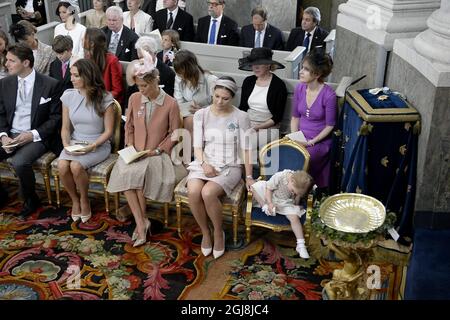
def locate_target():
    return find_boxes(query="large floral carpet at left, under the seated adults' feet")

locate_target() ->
[0,192,202,300]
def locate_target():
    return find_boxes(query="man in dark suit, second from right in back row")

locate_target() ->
[239,7,284,50]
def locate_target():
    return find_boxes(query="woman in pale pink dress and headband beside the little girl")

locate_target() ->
[187,76,254,259]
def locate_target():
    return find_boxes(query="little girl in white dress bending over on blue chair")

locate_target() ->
[251,170,313,259]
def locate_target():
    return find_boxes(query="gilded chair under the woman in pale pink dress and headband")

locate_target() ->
[174,177,246,246]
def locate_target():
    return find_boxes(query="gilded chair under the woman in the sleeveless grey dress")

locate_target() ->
[52,100,122,213]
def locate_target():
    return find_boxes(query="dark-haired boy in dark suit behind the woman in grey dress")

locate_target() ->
[49,35,73,95]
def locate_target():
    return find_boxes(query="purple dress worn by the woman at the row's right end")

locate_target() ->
[292,83,337,188]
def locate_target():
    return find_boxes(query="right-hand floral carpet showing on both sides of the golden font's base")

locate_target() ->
[221,239,407,300]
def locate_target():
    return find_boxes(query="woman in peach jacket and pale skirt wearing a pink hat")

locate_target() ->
[107,53,180,247]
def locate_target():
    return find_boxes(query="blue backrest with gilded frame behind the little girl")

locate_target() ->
[259,138,310,180]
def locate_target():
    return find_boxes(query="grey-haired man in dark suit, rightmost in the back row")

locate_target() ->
[286,7,329,53]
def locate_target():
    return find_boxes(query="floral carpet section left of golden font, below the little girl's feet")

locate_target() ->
[224,240,332,300]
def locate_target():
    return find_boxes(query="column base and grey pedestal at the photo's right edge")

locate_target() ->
[387,0,450,227]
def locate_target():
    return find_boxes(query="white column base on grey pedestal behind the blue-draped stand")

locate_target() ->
[332,0,440,88]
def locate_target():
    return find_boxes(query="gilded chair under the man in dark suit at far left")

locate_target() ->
[0,151,56,205]
